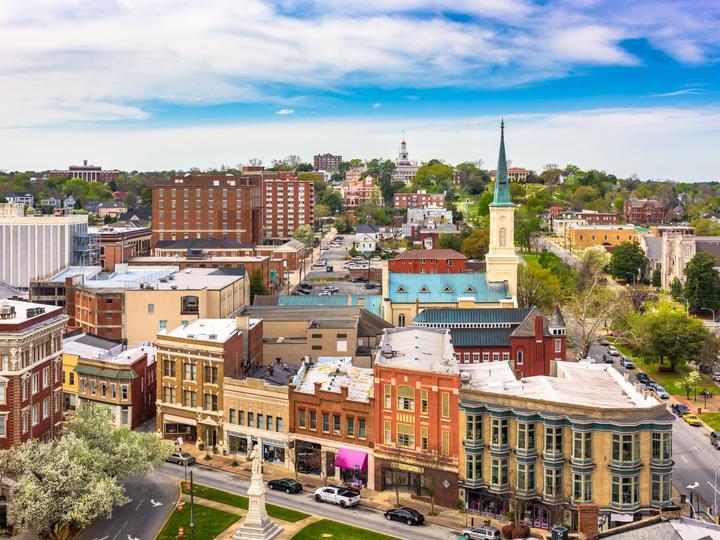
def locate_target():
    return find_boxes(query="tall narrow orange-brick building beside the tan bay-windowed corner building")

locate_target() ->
[374,328,460,507]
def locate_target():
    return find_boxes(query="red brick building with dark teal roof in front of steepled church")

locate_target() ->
[414,308,567,378]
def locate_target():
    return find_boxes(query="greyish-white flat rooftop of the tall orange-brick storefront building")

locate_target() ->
[375,326,459,374]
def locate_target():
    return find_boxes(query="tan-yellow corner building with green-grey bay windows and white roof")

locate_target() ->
[460,362,674,530]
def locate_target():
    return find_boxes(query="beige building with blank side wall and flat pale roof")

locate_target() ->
[124,268,250,344]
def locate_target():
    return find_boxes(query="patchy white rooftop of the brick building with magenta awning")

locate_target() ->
[293,356,375,403]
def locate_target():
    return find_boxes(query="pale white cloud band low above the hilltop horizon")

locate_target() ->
[0,107,720,181]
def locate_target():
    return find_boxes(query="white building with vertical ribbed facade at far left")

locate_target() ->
[0,204,89,289]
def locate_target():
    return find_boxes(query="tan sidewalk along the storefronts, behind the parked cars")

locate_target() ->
[183,445,550,538]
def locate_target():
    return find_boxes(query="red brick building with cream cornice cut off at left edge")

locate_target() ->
[0,300,66,450]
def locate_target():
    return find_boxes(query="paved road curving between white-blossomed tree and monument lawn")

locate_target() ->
[80,471,177,540]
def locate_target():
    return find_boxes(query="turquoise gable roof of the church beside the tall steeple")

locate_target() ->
[387,272,508,304]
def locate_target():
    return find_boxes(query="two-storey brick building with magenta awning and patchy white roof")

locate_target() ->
[288,357,375,489]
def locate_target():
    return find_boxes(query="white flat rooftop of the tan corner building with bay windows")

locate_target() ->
[460,361,660,409]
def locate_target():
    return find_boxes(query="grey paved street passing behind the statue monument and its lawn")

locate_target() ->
[158,463,455,540]
